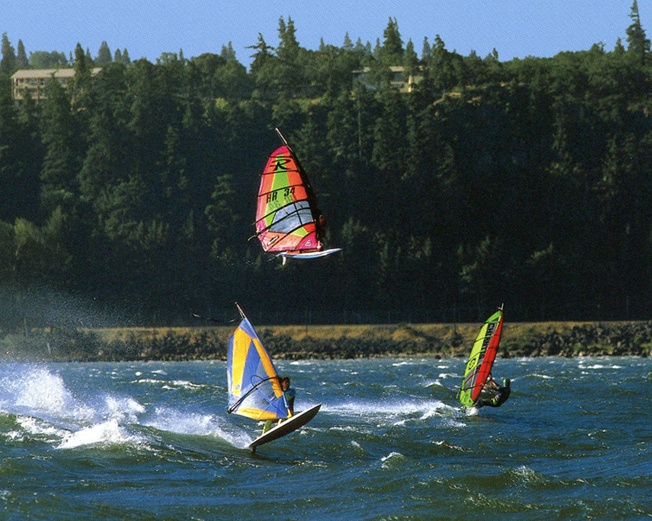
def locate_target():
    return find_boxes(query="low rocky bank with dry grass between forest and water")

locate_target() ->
[1,321,652,361]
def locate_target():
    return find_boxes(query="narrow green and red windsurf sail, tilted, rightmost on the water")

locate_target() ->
[459,308,503,407]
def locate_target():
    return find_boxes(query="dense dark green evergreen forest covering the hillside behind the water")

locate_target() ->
[0,6,652,330]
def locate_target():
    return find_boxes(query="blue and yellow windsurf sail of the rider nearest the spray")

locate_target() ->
[227,315,287,420]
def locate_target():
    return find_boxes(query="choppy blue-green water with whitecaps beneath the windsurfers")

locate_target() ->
[0,358,652,520]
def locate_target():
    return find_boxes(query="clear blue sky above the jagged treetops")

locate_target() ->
[5,0,652,67]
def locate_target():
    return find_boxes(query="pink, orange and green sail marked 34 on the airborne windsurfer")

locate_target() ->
[256,129,322,253]
